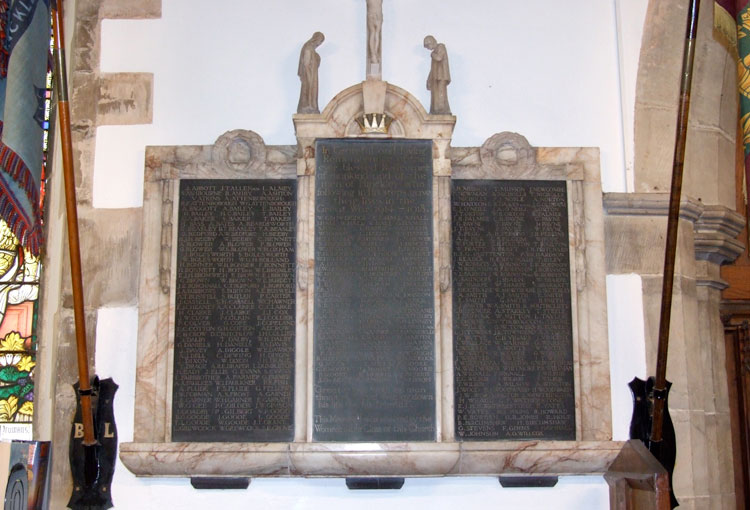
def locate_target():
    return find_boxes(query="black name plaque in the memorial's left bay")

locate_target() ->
[172,179,297,442]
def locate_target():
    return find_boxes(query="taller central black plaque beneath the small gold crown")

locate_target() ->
[313,140,435,441]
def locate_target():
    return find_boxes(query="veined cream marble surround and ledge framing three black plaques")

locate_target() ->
[120,71,623,477]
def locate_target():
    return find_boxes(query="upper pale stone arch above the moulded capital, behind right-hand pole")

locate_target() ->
[634,0,737,209]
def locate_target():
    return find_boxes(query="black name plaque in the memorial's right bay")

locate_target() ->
[451,180,576,440]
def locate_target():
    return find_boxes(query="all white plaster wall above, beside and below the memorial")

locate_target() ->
[93,0,645,510]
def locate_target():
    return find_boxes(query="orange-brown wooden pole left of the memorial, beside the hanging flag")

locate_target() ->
[52,0,96,446]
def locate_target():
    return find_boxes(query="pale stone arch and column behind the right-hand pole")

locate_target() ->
[628,0,741,506]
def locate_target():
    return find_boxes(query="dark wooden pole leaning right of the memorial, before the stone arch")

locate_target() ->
[651,0,700,442]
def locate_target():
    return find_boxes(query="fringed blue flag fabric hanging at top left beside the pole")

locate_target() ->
[0,0,50,255]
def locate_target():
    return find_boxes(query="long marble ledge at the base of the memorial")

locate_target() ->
[120,441,625,477]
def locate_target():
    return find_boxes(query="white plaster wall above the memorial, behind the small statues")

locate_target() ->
[94,0,636,207]
